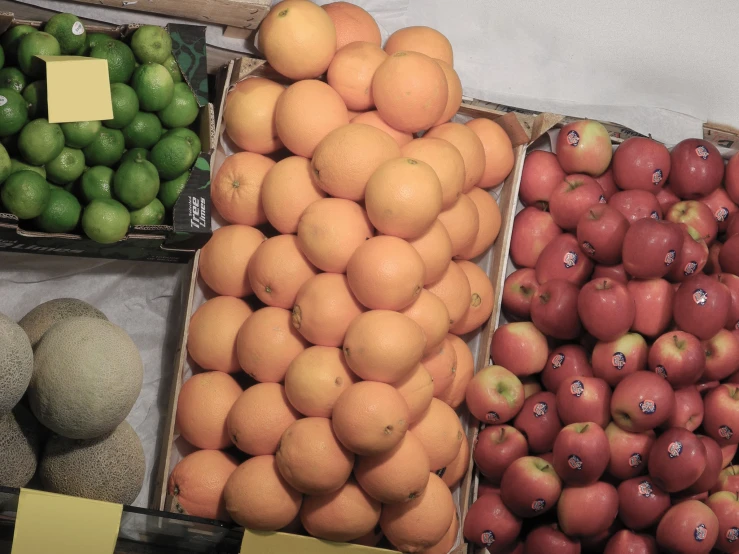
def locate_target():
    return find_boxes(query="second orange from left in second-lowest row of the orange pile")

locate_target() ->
[227,383,300,456]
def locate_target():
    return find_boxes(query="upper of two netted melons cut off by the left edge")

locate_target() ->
[0,314,33,414]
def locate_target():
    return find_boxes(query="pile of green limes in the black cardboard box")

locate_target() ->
[0,14,201,243]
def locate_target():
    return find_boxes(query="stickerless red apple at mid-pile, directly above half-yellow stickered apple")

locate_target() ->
[577,279,636,341]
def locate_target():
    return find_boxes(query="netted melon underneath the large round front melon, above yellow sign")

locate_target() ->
[39,421,146,504]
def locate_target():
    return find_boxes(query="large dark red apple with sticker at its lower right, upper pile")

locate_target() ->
[622,218,684,279]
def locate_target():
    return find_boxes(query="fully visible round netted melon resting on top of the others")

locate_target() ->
[28,317,144,439]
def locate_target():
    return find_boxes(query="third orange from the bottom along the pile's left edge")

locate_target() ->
[187,296,252,373]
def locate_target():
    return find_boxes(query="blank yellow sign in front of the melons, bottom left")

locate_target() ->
[11,489,123,554]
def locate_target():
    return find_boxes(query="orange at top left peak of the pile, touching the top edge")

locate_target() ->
[259,0,336,80]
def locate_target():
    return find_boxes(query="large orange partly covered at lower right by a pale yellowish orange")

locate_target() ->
[311,123,400,201]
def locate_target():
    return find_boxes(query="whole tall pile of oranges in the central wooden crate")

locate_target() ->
[169,0,513,553]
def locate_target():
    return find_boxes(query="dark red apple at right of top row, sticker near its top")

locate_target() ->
[670,139,724,200]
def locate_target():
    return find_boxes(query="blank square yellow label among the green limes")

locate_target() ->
[39,56,113,123]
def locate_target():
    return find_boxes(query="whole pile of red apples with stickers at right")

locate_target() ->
[464,121,739,554]
